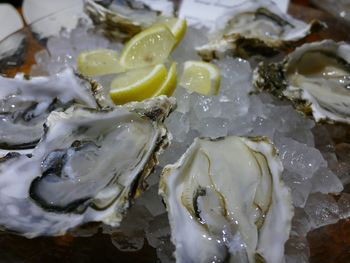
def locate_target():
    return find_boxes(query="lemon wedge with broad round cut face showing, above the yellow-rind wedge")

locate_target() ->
[120,25,176,68]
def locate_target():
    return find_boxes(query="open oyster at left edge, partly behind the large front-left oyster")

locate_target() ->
[0,69,97,153]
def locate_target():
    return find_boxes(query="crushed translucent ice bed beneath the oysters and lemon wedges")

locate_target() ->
[31,23,350,262]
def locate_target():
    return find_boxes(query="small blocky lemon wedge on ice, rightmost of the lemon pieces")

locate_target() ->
[180,61,221,96]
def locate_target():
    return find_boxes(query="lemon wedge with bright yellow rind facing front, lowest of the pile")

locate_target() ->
[110,64,167,104]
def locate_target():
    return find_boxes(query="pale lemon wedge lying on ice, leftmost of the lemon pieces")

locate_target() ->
[77,49,124,77]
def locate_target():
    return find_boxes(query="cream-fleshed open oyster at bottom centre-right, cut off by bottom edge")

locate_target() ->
[159,136,293,263]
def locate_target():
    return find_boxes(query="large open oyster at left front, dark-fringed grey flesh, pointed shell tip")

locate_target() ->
[0,96,174,237]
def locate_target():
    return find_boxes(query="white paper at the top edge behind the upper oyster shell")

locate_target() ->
[179,0,289,27]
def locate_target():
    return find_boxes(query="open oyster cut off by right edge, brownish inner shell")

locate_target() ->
[253,40,350,124]
